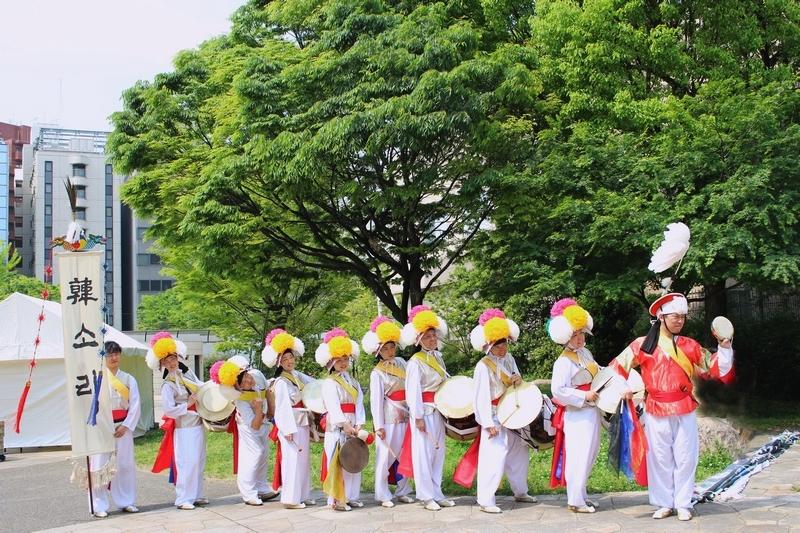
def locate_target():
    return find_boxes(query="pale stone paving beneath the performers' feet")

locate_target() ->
[40,445,800,533]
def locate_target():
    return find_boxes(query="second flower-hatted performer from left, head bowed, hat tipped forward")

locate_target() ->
[218,355,277,505]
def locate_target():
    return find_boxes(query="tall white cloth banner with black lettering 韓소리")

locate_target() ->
[55,251,114,457]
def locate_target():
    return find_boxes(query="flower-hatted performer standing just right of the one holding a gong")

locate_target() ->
[361,316,414,507]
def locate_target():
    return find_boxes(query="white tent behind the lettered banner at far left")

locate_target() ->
[0,293,153,448]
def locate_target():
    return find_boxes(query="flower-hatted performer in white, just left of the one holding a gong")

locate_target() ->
[261,329,316,509]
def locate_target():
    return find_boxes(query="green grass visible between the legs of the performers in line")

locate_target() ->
[135,424,732,496]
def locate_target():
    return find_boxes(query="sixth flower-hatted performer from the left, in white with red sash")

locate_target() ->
[399,305,456,511]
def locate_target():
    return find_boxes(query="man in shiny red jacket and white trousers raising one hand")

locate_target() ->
[610,293,734,520]
